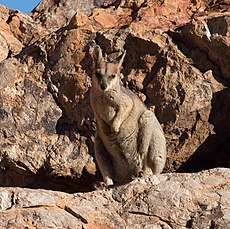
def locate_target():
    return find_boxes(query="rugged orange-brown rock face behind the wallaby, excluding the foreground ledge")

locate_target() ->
[0,0,230,202]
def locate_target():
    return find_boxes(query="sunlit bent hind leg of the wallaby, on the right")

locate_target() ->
[138,110,166,174]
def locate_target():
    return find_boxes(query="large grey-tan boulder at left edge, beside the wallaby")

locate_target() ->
[0,59,95,191]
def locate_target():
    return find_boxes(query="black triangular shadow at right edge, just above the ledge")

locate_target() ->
[178,88,230,172]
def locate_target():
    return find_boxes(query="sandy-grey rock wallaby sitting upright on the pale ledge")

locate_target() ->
[90,46,166,186]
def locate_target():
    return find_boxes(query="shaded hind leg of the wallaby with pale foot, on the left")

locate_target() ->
[94,133,113,186]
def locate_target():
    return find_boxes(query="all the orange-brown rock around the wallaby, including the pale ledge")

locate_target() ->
[0,0,230,226]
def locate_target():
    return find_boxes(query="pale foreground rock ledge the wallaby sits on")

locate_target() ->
[0,168,230,229]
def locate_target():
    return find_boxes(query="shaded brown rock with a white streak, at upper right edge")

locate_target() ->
[169,12,230,80]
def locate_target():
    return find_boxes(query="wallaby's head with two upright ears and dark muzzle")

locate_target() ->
[92,46,126,91]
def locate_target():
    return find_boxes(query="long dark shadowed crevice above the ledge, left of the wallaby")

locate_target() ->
[0,156,96,193]
